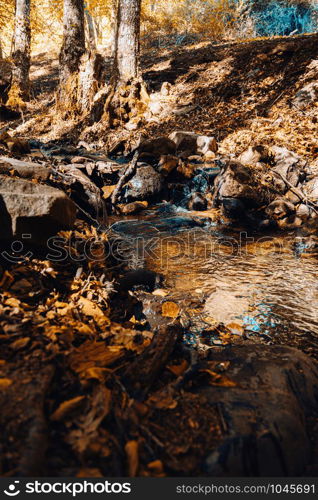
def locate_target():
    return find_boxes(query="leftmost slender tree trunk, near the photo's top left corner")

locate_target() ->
[8,0,31,106]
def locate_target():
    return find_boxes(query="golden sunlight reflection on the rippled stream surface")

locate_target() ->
[146,230,318,335]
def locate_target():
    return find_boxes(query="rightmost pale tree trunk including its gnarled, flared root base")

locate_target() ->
[82,0,150,138]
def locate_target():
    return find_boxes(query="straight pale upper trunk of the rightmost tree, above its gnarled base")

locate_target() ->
[115,0,141,82]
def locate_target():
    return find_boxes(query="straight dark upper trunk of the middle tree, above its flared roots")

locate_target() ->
[60,0,85,84]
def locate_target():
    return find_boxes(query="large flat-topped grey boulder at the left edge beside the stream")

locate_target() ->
[0,176,76,244]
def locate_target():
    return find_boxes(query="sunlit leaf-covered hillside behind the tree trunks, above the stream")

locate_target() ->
[11,34,318,166]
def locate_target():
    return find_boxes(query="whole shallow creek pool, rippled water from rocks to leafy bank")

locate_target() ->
[110,207,318,348]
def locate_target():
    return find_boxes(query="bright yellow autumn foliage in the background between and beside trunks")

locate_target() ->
[0,0,256,57]
